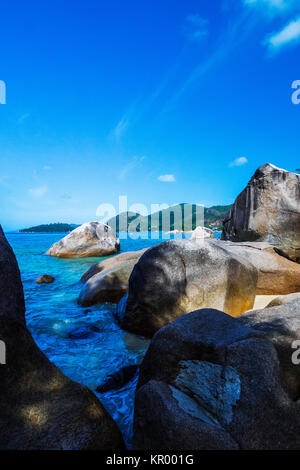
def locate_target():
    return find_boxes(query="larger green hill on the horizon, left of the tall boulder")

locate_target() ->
[107,203,231,232]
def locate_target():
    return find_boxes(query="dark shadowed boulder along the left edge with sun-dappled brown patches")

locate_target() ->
[0,227,124,450]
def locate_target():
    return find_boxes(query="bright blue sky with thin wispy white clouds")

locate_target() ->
[0,0,300,230]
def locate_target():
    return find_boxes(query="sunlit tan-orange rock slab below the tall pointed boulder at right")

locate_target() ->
[219,240,300,295]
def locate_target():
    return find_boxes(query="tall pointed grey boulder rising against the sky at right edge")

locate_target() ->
[222,163,300,262]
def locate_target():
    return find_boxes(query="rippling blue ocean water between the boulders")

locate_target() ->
[6,233,220,447]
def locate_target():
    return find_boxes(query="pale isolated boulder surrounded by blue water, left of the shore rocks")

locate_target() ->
[46,222,120,258]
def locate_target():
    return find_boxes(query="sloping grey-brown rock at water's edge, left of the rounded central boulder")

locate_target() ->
[78,249,146,306]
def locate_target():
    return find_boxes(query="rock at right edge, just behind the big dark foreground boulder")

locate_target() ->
[238,302,300,400]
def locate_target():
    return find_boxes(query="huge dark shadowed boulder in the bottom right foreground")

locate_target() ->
[133,309,300,451]
